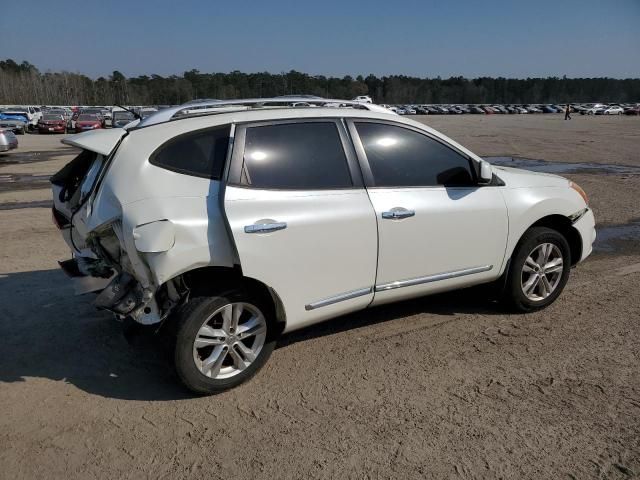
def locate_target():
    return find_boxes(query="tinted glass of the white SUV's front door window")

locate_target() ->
[356,122,474,187]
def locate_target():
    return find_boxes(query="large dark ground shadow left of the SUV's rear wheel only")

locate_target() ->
[0,270,192,401]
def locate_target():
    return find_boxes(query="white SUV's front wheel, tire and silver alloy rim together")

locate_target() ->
[505,227,571,312]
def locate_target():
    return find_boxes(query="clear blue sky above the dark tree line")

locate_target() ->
[0,0,640,78]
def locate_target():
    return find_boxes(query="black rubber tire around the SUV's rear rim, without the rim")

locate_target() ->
[173,290,277,395]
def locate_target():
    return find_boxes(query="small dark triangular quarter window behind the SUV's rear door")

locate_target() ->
[149,125,231,180]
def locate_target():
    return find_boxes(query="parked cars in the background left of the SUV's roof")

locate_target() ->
[0,105,158,135]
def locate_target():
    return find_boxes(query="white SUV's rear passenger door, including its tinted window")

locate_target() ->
[224,119,377,330]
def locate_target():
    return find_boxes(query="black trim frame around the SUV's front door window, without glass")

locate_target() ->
[345,117,482,189]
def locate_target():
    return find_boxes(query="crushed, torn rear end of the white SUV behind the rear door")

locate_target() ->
[51,125,233,325]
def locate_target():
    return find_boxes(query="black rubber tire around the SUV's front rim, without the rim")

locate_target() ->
[503,227,571,312]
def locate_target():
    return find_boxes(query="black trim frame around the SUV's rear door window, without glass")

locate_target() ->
[227,117,364,192]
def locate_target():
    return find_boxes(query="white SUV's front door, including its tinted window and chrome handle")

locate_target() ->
[351,121,508,304]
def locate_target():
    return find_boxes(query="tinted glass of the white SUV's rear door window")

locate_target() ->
[241,122,352,190]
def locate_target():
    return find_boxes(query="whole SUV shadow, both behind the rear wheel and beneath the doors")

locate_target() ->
[0,270,501,401]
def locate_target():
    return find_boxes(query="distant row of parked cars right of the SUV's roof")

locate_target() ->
[382,103,640,115]
